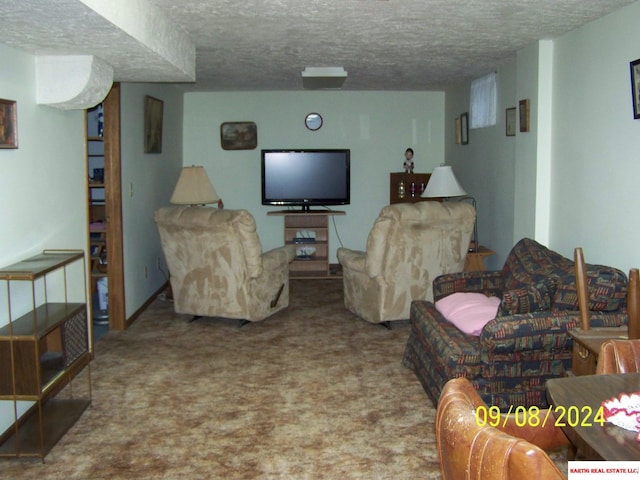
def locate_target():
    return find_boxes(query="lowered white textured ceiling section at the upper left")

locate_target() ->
[0,0,195,82]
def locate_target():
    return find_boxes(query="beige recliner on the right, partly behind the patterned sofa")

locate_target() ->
[338,202,475,325]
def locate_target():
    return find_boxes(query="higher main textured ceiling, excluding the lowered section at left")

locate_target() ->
[153,0,631,90]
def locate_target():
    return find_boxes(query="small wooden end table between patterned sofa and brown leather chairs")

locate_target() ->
[567,325,628,376]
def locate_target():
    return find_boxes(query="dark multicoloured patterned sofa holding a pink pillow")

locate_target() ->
[402,238,627,409]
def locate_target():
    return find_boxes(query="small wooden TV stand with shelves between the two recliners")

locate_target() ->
[267,210,346,279]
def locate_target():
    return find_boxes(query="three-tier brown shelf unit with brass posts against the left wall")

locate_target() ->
[0,250,92,462]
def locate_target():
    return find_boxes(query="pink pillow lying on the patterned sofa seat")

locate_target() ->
[435,292,500,336]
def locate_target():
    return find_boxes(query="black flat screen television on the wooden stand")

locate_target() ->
[261,149,351,210]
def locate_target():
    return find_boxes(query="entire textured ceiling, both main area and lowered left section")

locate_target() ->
[0,0,633,90]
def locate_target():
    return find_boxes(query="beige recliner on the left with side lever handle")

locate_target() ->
[154,207,295,322]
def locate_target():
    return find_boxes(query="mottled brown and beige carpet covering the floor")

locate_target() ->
[0,280,448,480]
